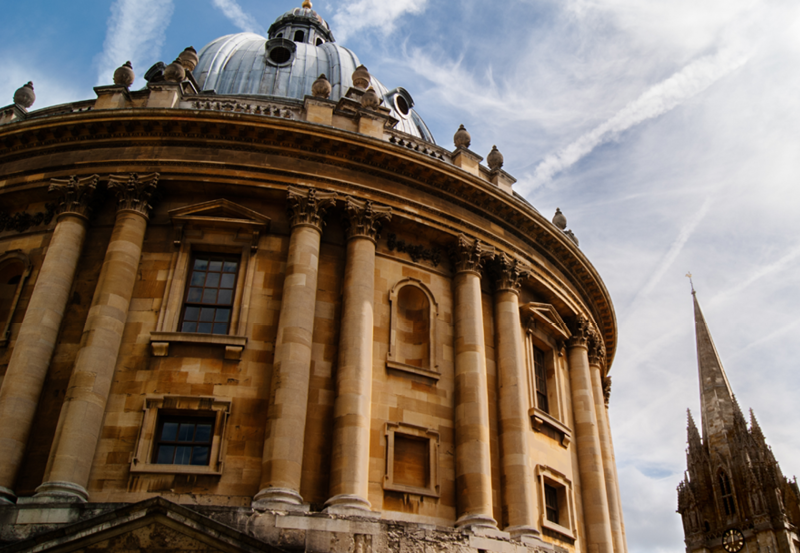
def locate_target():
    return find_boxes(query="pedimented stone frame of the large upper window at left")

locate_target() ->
[150,199,270,361]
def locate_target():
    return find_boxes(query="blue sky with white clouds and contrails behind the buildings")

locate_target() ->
[0,0,800,553]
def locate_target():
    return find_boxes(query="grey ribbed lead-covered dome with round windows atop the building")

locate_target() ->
[193,2,435,142]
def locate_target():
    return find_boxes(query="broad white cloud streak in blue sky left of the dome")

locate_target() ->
[97,0,174,86]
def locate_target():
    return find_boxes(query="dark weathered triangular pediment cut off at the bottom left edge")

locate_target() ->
[8,497,278,553]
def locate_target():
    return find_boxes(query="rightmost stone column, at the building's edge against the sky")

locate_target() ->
[588,332,627,553]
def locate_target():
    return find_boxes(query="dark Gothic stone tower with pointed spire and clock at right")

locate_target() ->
[678,290,800,553]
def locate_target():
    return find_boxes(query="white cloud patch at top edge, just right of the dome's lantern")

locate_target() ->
[333,0,428,41]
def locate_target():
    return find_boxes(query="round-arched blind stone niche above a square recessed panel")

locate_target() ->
[386,278,439,380]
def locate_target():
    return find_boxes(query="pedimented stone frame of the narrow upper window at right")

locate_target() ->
[520,302,572,448]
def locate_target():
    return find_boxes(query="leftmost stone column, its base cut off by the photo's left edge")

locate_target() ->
[0,175,98,504]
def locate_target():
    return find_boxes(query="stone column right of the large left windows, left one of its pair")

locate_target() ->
[253,187,336,508]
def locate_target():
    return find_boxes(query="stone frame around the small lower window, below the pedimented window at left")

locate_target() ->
[130,394,233,476]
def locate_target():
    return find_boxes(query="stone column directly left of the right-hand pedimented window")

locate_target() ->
[493,253,539,537]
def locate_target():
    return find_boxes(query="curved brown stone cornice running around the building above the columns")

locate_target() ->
[0,108,616,366]
